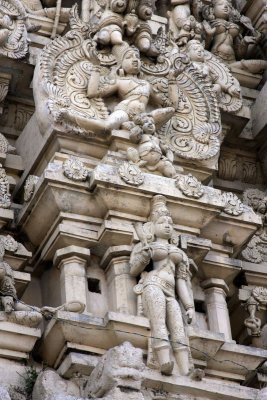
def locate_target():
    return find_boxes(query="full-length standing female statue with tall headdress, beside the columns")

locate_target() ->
[130,195,195,375]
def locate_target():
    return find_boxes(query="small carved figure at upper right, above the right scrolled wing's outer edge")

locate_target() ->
[186,40,240,97]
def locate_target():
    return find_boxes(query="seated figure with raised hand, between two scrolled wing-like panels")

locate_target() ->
[61,43,174,134]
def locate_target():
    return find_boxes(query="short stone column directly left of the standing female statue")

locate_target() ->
[101,246,136,315]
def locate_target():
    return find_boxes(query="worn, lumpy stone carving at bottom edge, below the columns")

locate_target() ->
[32,342,145,400]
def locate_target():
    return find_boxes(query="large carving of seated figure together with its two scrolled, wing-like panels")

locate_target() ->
[34,3,226,160]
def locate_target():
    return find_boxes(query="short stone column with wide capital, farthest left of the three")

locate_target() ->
[54,246,90,305]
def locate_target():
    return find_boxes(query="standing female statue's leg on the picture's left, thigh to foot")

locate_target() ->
[142,285,173,375]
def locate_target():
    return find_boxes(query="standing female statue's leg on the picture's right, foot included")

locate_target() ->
[167,297,190,375]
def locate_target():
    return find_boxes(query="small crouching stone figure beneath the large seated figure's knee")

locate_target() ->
[126,113,177,178]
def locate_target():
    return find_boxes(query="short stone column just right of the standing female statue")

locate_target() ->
[201,278,232,341]
